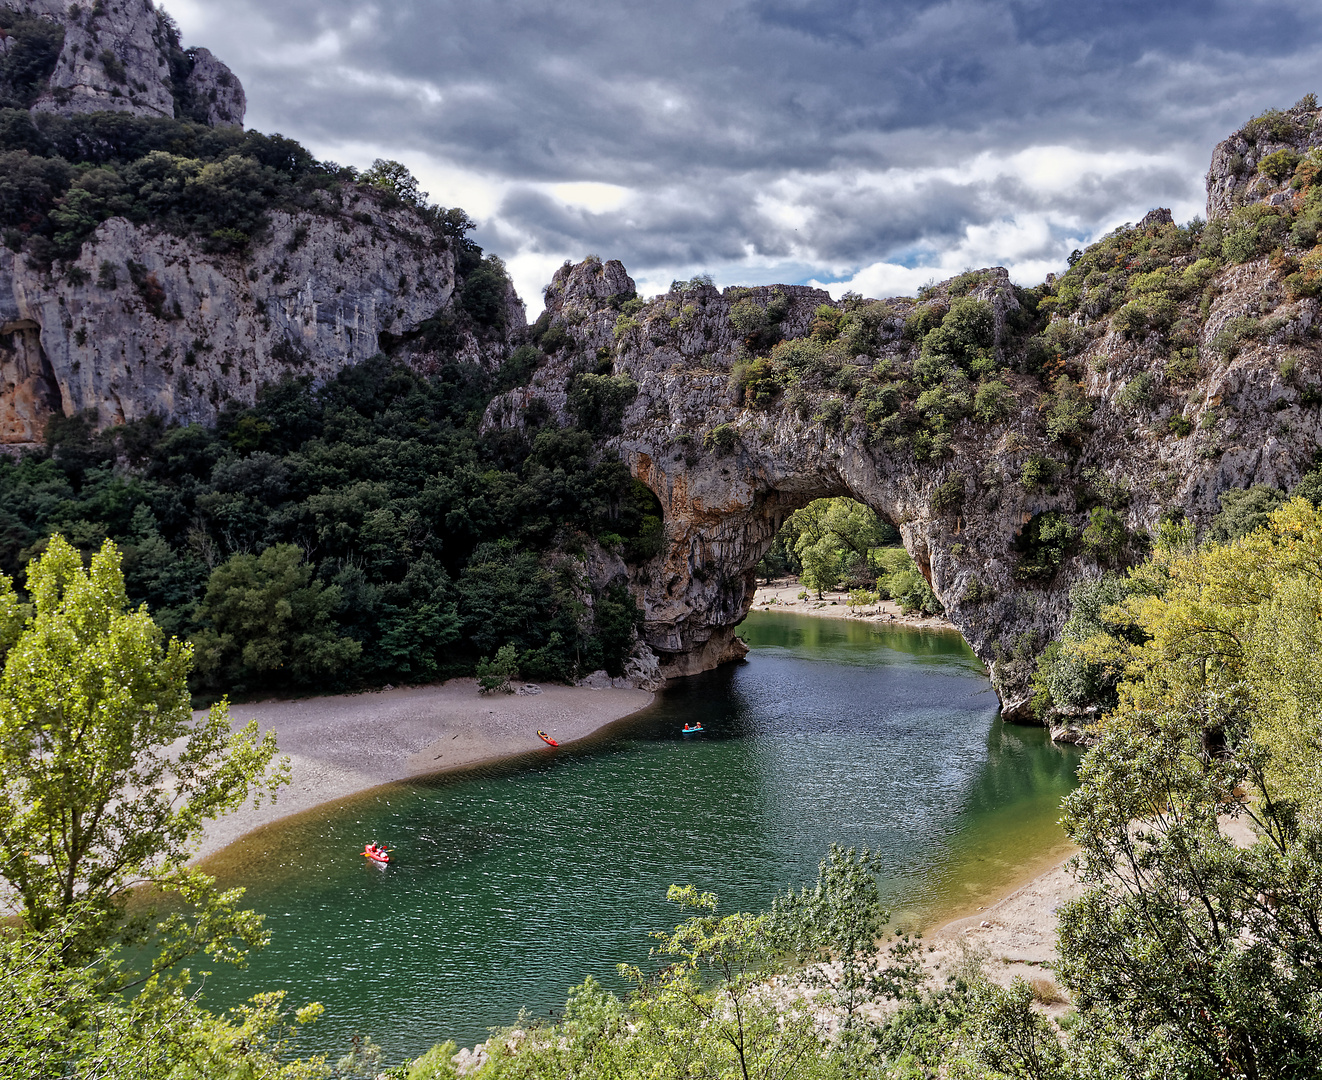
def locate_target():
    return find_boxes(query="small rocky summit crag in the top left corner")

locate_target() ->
[9,0,247,126]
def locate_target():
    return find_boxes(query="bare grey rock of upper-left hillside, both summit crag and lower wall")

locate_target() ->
[0,0,526,448]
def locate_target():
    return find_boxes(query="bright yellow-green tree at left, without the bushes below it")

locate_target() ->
[0,535,288,970]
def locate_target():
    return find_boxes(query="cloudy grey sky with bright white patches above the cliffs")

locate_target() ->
[164,0,1322,313]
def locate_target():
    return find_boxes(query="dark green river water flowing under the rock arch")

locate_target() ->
[198,612,1077,1060]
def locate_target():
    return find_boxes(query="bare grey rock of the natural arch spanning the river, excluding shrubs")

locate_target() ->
[484,251,1322,716]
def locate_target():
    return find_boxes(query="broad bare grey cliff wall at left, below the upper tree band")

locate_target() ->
[0,189,526,444]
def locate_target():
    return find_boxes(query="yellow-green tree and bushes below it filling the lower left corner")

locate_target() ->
[0,535,327,1080]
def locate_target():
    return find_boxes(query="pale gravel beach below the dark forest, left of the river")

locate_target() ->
[197,678,653,859]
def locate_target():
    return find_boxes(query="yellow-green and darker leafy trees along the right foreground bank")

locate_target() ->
[1060,498,1322,1077]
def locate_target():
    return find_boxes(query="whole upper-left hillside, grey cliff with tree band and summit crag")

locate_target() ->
[0,0,526,445]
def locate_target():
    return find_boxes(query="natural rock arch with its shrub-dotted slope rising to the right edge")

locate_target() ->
[485,106,1322,716]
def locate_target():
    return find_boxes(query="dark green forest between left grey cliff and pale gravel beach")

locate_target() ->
[0,358,660,695]
